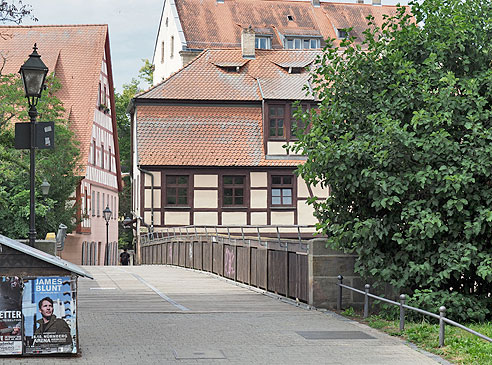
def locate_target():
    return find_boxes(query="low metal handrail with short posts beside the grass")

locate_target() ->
[337,275,492,347]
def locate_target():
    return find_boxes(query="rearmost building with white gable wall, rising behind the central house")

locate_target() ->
[152,0,404,85]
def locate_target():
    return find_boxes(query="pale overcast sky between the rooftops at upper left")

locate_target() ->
[24,0,408,92]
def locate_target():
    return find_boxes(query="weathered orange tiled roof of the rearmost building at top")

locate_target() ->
[175,0,404,49]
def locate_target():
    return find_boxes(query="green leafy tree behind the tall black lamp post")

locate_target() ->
[0,74,79,238]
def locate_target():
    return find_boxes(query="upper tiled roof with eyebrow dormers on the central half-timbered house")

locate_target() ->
[137,49,320,101]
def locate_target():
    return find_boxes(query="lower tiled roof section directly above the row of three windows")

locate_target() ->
[137,105,299,167]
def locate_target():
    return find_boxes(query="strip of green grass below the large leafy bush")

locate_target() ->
[342,308,492,365]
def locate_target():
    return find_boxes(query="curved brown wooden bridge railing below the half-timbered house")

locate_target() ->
[141,226,309,303]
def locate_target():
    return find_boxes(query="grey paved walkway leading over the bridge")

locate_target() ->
[0,266,446,365]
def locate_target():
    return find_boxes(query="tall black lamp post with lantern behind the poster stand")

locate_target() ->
[19,44,48,246]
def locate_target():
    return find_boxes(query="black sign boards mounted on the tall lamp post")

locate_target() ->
[15,122,55,150]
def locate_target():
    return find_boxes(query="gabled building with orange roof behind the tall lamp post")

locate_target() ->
[0,25,122,265]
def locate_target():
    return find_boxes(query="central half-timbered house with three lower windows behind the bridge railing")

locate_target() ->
[131,34,328,242]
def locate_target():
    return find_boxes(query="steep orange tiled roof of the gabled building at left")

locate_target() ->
[0,25,121,186]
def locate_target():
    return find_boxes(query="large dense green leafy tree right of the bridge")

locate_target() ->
[295,0,492,320]
